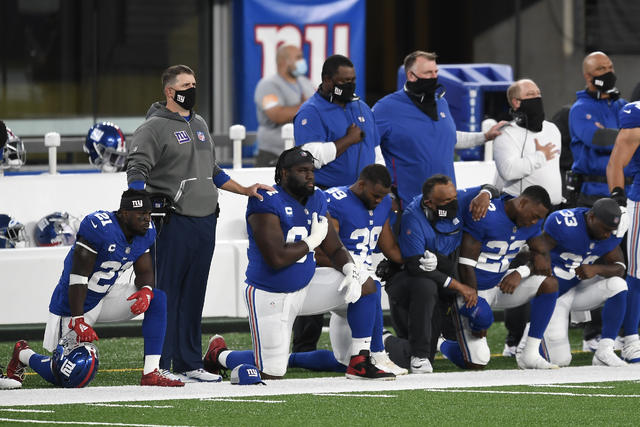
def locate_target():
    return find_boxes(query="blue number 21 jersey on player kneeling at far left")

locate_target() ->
[49,211,156,316]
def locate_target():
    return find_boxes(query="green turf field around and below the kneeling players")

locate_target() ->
[5,323,640,426]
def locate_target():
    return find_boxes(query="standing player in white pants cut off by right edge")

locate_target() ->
[607,101,640,363]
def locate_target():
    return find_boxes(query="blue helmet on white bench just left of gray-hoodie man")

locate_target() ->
[84,122,127,172]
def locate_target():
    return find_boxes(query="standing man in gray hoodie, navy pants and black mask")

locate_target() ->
[127,65,272,381]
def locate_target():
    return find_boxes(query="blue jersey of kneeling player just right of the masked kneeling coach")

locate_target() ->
[463,196,544,290]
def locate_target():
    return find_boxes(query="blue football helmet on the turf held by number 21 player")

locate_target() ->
[51,331,98,388]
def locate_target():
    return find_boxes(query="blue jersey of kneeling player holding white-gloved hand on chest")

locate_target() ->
[246,185,327,292]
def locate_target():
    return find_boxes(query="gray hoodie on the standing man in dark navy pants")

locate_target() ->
[127,102,224,217]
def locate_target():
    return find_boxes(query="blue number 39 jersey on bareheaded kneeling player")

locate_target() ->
[325,186,391,266]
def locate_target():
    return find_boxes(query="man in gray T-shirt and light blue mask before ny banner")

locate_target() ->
[254,45,313,167]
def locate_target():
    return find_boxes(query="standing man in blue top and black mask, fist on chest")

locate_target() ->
[293,55,384,188]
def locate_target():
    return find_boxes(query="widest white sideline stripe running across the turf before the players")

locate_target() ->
[0,365,640,407]
